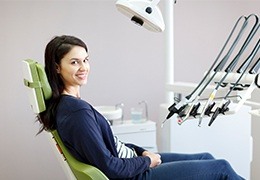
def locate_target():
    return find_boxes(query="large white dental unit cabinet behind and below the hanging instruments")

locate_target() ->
[157,83,253,179]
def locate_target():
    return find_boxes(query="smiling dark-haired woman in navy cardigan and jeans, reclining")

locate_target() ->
[38,35,242,180]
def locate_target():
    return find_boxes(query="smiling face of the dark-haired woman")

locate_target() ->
[57,46,90,89]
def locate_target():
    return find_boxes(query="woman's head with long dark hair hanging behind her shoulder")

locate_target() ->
[38,35,90,133]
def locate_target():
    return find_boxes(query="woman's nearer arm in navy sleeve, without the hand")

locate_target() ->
[59,109,151,178]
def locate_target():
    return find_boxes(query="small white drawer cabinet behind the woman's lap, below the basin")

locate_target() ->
[111,121,157,152]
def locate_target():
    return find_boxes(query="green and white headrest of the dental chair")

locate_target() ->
[23,59,52,113]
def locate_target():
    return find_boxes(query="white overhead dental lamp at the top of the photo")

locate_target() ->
[116,0,165,32]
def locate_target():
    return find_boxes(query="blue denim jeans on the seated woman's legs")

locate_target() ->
[143,153,243,180]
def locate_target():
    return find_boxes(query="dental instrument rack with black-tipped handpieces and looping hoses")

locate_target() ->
[165,14,260,126]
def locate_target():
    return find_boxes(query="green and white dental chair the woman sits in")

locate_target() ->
[23,59,108,180]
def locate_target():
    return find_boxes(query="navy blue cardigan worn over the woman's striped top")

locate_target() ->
[56,95,151,179]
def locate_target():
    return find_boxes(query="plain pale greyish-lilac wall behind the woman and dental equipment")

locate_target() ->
[0,0,260,180]
